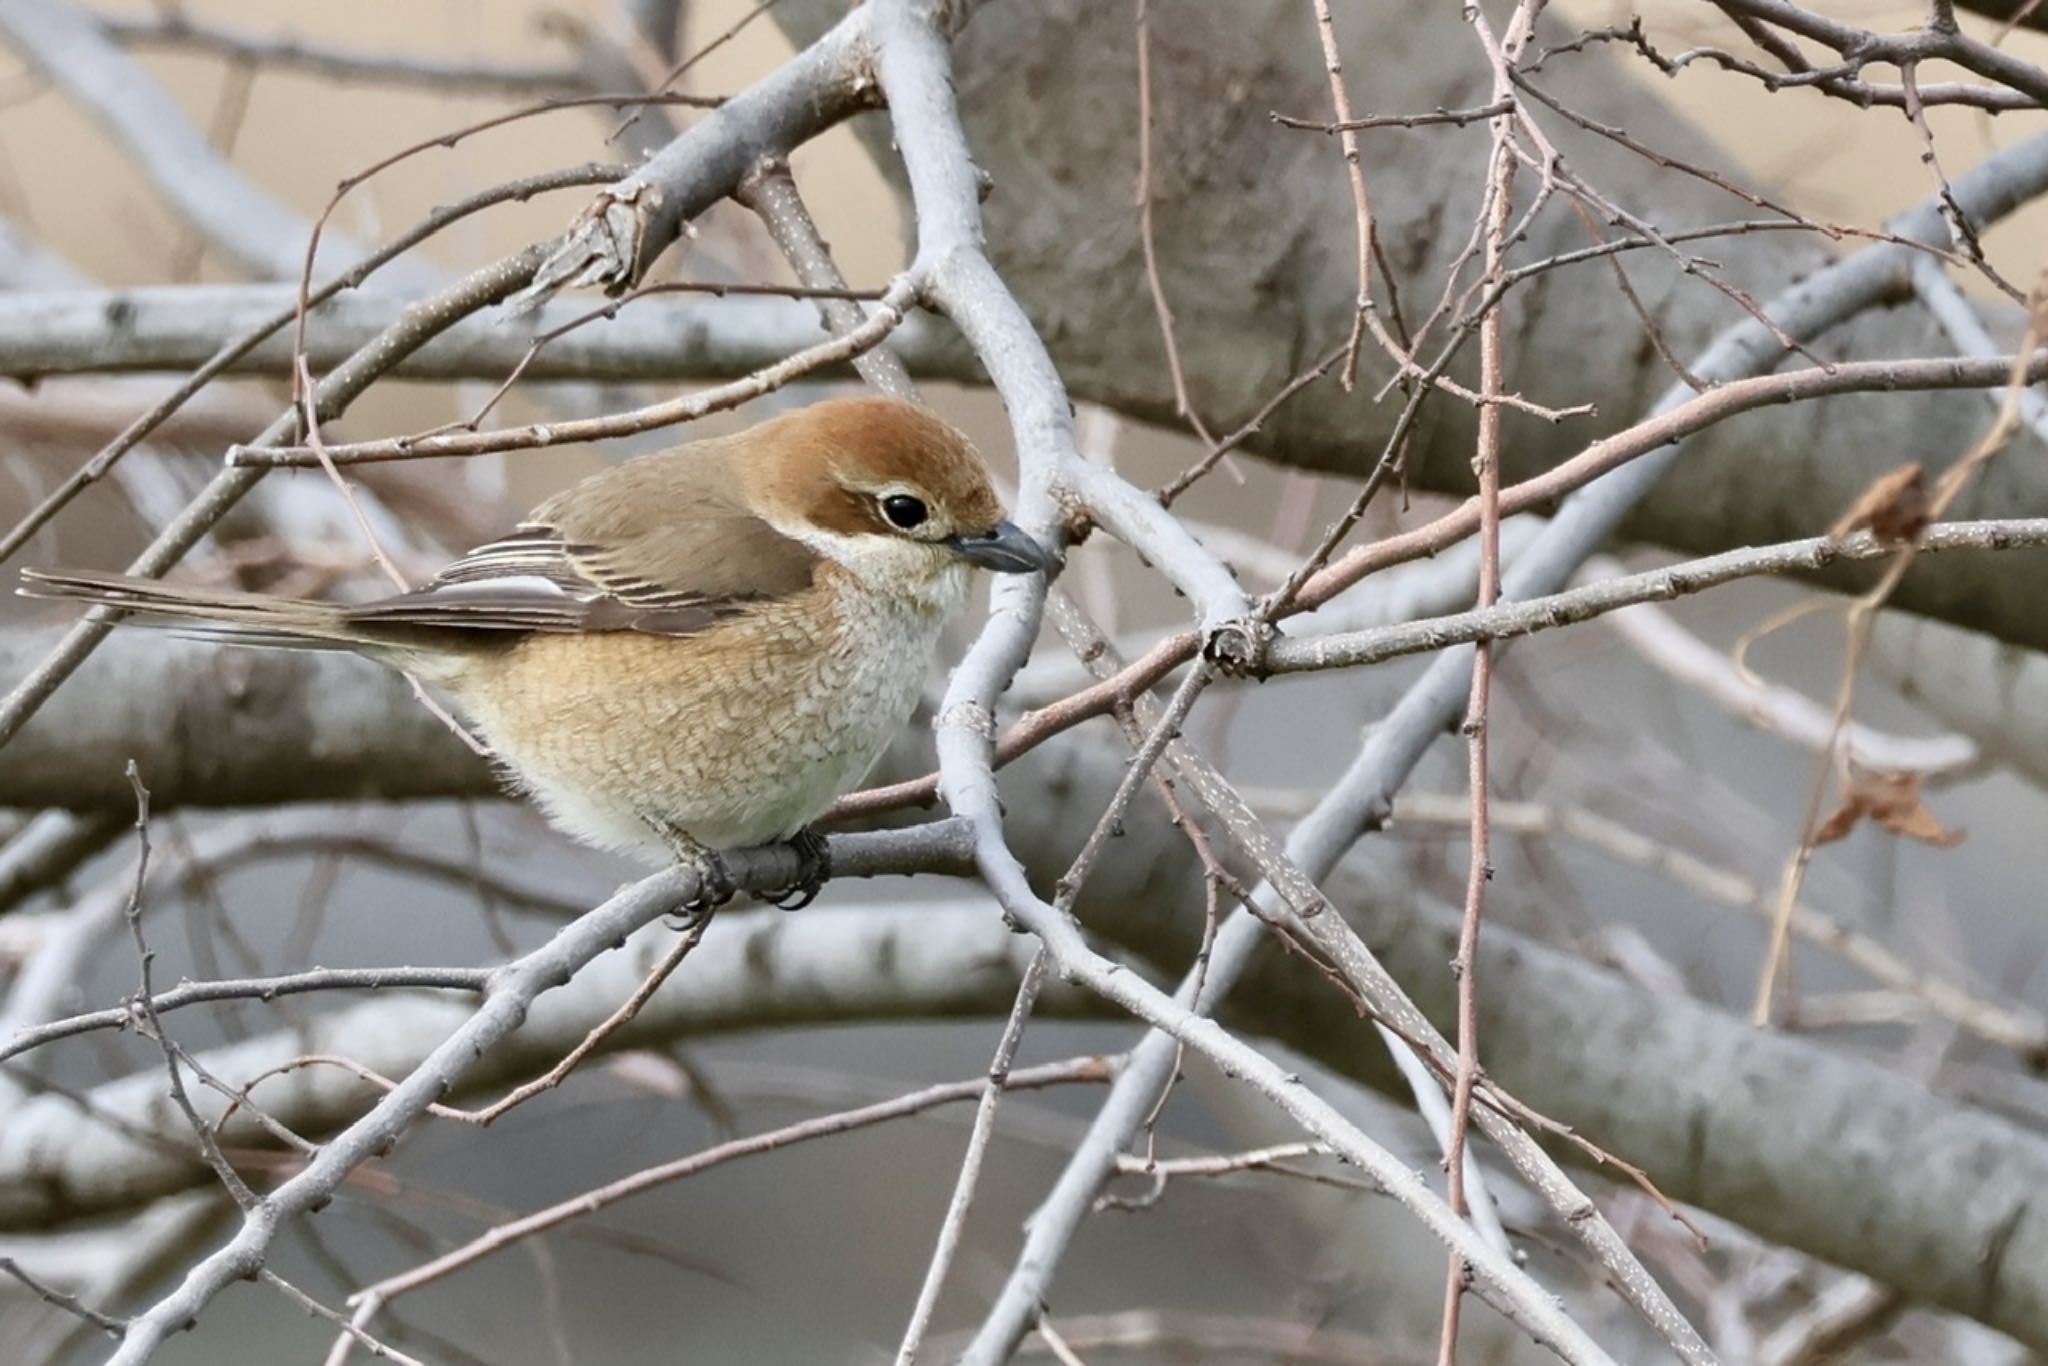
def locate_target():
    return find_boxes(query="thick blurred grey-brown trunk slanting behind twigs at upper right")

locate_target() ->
[774,0,2048,649]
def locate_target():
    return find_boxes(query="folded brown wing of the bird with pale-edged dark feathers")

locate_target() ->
[348,508,813,635]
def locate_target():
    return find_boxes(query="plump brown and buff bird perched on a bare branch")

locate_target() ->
[20,395,1055,905]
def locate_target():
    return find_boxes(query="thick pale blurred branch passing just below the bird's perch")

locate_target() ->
[0,903,1102,1231]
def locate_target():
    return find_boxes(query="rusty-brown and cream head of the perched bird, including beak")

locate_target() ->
[741,397,1053,608]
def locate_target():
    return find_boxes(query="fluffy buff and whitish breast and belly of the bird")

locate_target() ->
[451,573,944,862]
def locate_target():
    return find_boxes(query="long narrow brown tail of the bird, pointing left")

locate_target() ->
[20,569,370,649]
